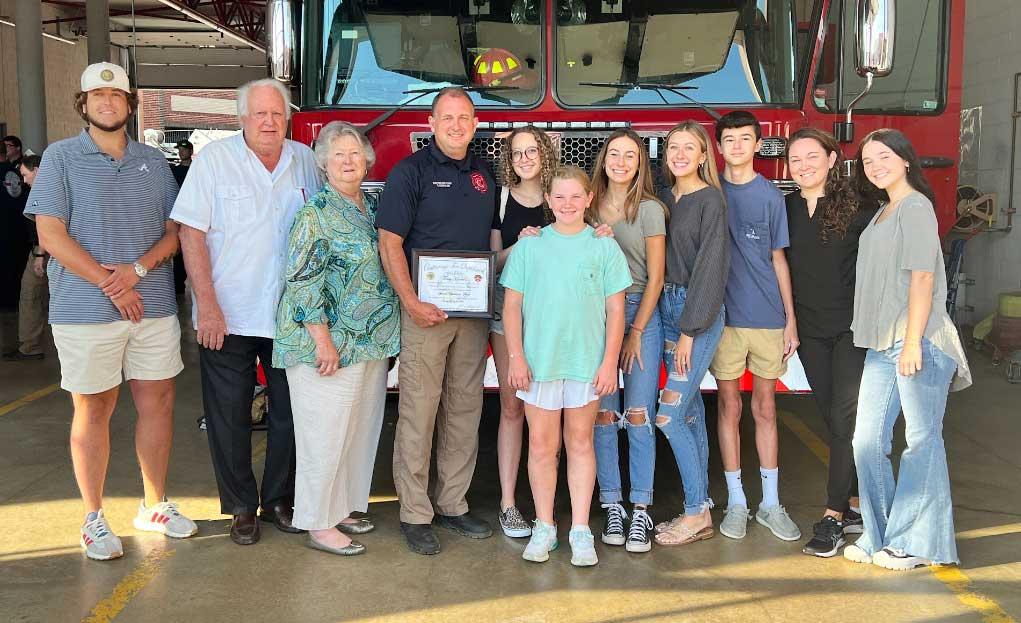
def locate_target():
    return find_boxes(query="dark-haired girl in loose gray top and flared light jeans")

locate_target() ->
[844,130,971,570]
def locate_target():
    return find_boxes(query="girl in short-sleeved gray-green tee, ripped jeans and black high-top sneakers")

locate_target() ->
[586,130,667,552]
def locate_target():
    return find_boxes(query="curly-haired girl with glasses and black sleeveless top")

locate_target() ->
[489,126,556,537]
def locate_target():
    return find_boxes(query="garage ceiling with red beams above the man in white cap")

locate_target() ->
[43,0,266,88]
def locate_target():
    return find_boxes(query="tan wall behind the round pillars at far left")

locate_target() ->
[0,0,89,152]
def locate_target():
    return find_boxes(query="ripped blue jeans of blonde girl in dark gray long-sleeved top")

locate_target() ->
[655,283,724,515]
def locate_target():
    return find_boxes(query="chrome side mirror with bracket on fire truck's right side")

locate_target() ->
[833,0,896,143]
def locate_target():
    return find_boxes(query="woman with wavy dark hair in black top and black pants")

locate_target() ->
[786,128,875,558]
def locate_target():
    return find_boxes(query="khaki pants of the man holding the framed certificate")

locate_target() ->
[393,313,489,524]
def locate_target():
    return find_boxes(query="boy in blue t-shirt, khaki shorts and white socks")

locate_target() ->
[710,110,801,540]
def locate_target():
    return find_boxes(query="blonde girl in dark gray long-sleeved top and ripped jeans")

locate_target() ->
[655,121,730,545]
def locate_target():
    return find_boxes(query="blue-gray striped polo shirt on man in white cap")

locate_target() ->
[25,130,178,325]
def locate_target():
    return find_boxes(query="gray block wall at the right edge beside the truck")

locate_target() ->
[961,0,1021,322]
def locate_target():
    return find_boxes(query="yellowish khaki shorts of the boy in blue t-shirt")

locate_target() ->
[709,327,787,381]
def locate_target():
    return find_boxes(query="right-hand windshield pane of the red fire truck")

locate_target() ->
[553,0,797,107]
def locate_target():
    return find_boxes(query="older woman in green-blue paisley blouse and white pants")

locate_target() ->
[273,122,400,556]
